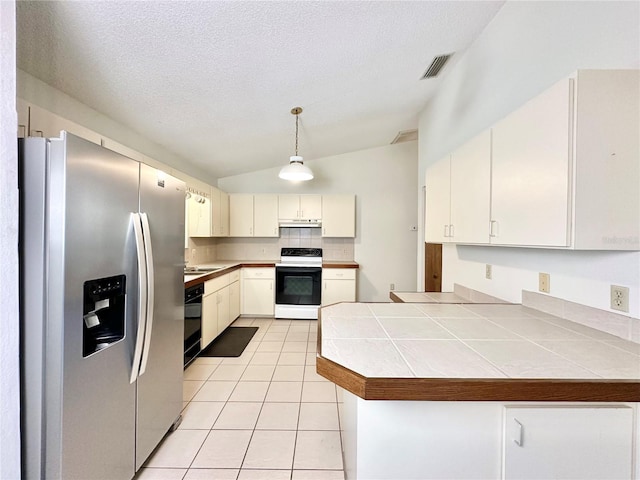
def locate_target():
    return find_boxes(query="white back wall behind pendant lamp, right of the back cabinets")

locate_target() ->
[218,142,418,302]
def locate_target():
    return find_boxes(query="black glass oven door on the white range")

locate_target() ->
[276,266,322,307]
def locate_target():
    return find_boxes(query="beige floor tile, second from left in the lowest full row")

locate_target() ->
[191,430,253,468]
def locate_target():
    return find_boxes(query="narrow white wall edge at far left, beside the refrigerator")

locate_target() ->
[0,0,20,479]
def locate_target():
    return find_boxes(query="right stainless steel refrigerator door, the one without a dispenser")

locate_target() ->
[136,164,185,470]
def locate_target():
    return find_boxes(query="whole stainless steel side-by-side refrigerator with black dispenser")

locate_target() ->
[19,132,185,480]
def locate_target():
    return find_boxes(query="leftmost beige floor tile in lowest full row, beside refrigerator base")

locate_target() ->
[147,429,209,468]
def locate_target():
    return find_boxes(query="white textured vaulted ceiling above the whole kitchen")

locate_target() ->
[17,1,504,178]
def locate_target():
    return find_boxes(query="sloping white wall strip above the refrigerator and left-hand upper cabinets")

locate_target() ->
[17,69,215,184]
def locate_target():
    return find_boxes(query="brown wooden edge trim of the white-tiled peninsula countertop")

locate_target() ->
[316,310,640,402]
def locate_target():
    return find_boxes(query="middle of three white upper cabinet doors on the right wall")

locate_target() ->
[449,130,491,244]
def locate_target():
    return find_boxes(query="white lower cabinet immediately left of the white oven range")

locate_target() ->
[241,267,276,315]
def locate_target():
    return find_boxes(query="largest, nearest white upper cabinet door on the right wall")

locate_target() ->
[491,79,573,246]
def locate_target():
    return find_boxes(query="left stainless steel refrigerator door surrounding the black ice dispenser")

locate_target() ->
[56,135,138,479]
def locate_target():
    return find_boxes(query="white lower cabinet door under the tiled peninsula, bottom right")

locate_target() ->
[503,406,633,480]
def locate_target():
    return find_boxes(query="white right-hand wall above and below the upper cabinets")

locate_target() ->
[419,1,640,318]
